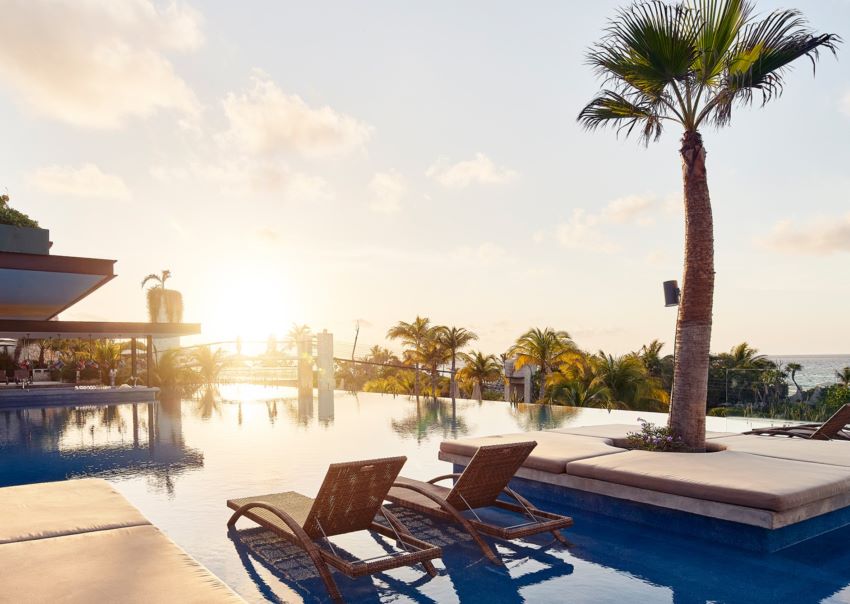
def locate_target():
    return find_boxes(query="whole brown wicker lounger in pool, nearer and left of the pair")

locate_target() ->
[227,457,441,600]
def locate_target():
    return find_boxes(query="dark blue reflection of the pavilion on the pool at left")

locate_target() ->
[0,399,204,492]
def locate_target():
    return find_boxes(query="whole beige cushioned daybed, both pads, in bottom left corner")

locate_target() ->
[0,478,244,604]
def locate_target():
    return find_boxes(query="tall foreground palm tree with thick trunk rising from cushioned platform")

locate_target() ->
[578,0,840,450]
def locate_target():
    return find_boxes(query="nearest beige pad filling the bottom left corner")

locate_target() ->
[0,525,243,604]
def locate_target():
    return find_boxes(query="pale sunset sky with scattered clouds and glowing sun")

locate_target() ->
[0,0,850,354]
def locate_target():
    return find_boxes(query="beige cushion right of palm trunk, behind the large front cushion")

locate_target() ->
[715,434,850,467]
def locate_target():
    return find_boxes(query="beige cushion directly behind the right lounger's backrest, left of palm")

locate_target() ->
[440,432,623,474]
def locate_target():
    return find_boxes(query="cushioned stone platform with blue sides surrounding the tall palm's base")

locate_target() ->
[439,424,850,551]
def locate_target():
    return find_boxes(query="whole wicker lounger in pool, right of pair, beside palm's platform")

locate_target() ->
[387,441,573,564]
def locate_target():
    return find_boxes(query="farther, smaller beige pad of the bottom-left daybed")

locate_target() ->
[0,478,150,543]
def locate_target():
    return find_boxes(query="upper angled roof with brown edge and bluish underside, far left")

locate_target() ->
[0,252,115,320]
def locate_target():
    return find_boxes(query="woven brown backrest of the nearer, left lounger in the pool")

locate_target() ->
[304,456,407,538]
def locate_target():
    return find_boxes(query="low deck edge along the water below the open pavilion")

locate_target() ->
[0,384,159,409]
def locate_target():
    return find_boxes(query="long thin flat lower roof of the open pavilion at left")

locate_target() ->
[0,319,201,340]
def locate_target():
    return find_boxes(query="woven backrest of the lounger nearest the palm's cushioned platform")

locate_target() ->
[446,441,537,510]
